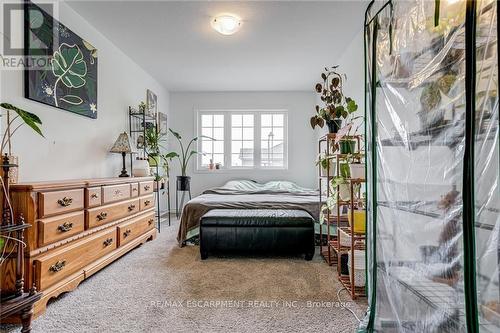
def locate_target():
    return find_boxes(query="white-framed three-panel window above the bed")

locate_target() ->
[198,110,288,170]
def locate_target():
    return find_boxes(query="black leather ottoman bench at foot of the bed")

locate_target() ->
[200,209,314,260]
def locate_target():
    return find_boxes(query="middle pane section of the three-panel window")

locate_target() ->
[231,114,254,167]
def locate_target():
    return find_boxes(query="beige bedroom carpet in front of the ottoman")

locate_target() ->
[0,218,366,333]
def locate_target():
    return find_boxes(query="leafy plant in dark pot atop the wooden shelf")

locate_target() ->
[310,66,358,133]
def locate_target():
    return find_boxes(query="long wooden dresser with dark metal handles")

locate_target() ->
[0,177,156,317]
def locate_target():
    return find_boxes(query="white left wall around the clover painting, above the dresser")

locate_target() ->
[0,3,169,181]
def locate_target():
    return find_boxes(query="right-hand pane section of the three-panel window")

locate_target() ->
[260,114,285,168]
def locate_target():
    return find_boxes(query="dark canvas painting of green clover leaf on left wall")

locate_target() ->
[24,2,97,119]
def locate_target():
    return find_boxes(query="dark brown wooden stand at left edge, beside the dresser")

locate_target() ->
[0,154,42,333]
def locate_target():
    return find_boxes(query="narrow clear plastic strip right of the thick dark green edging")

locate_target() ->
[474,1,500,332]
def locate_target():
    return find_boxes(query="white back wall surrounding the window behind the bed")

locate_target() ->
[170,89,317,195]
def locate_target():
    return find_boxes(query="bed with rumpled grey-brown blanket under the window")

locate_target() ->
[177,180,320,246]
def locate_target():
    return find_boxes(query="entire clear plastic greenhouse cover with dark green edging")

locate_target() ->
[362,0,500,333]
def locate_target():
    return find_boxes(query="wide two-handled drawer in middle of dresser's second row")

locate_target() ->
[85,198,139,229]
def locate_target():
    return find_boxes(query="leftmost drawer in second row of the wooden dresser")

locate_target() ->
[38,211,85,246]
